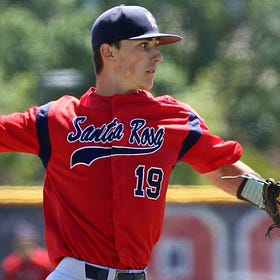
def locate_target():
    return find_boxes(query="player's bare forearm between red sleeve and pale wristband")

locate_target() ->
[203,160,261,196]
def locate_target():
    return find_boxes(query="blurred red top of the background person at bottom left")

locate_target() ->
[2,247,52,280]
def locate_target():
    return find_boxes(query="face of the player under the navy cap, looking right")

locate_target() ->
[112,39,163,92]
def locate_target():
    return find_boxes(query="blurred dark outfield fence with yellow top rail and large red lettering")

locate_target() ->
[0,186,280,280]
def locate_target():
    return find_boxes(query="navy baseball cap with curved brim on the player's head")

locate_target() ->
[91,5,182,49]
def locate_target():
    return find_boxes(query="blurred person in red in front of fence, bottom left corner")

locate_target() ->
[2,222,52,280]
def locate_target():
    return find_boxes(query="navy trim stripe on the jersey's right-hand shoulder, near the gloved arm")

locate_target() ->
[178,112,201,161]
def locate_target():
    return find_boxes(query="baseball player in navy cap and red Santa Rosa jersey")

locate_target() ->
[0,5,266,280]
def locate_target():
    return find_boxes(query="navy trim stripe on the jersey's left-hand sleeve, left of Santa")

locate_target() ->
[36,102,51,168]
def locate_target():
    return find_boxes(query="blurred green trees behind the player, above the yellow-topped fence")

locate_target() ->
[0,0,280,185]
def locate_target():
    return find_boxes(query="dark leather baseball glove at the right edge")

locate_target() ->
[263,179,280,238]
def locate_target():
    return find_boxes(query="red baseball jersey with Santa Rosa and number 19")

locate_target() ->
[0,88,242,269]
